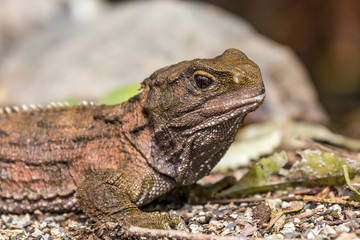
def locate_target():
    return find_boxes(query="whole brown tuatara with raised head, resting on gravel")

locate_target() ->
[0,49,264,228]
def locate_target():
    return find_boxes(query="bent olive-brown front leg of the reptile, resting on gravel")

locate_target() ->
[76,170,180,229]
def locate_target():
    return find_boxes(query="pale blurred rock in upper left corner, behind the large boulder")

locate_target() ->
[0,0,101,57]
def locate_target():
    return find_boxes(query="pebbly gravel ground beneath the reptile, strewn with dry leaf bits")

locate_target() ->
[0,187,360,240]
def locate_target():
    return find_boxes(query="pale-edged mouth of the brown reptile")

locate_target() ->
[183,93,265,135]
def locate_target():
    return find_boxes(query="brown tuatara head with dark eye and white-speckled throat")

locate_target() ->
[143,49,265,185]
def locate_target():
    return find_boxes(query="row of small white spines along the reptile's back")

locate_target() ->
[0,100,95,114]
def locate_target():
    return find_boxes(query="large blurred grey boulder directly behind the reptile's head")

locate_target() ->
[0,1,327,122]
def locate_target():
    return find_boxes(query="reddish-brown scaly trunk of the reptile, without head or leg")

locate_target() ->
[0,97,150,212]
